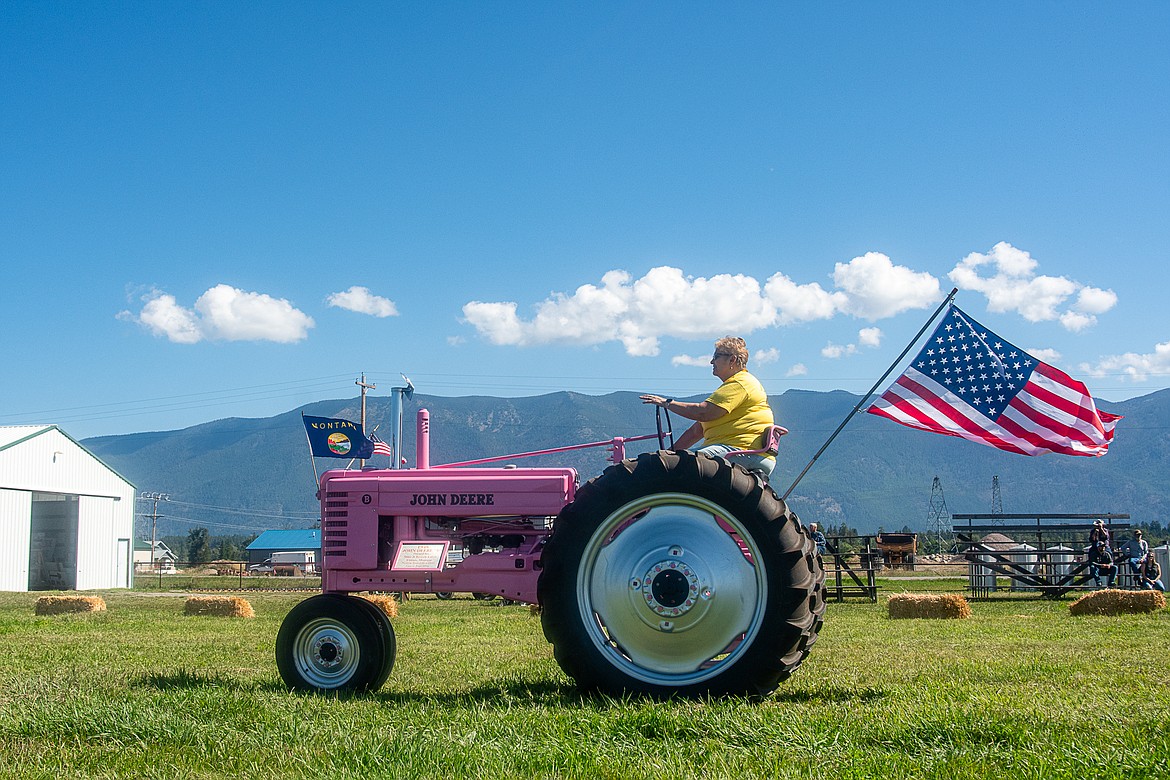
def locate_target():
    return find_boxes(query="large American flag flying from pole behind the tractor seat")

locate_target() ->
[868,305,1121,456]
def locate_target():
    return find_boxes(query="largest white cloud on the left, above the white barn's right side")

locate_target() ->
[121,284,315,344]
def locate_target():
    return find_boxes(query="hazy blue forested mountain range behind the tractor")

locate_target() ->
[82,389,1170,534]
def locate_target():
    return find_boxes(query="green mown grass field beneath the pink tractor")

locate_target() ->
[0,581,1170,779]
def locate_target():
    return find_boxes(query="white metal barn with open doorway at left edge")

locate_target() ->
[0,426,135,591]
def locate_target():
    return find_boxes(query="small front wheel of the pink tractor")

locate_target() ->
[276,594,394,693]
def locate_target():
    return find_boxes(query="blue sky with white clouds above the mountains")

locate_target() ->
[0,0,1170,437]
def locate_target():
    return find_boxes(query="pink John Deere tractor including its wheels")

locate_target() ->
[276,388,825,698]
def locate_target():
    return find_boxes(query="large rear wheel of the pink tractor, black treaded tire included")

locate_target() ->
[537,450,825,698]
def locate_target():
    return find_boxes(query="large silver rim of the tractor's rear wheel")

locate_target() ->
[577,493,768,685]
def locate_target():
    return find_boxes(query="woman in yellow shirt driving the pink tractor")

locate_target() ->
[640,336,776,476]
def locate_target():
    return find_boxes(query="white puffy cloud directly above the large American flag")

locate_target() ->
[949,241,1117,331]
